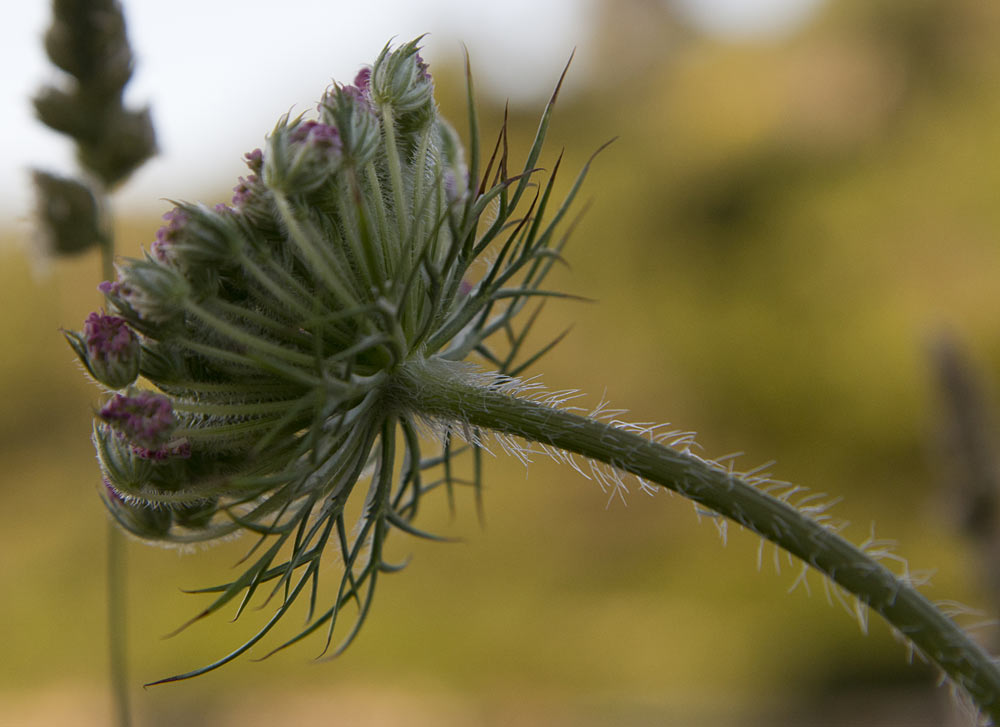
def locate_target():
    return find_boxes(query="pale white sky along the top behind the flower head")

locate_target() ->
[0,0,821,228]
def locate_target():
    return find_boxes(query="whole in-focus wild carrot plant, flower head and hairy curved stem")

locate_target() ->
[68,41,1000,719]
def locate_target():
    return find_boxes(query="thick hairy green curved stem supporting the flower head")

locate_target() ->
[393,361,1000,722]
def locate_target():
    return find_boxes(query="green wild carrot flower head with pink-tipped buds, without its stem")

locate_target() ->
[70,41,600,676]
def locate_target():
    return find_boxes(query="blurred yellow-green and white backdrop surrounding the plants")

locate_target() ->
[0,0,1000,727]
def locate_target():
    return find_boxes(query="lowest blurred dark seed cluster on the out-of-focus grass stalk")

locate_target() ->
[31,170,101,255]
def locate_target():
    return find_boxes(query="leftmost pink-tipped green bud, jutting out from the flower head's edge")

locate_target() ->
[66,313,141,389]
